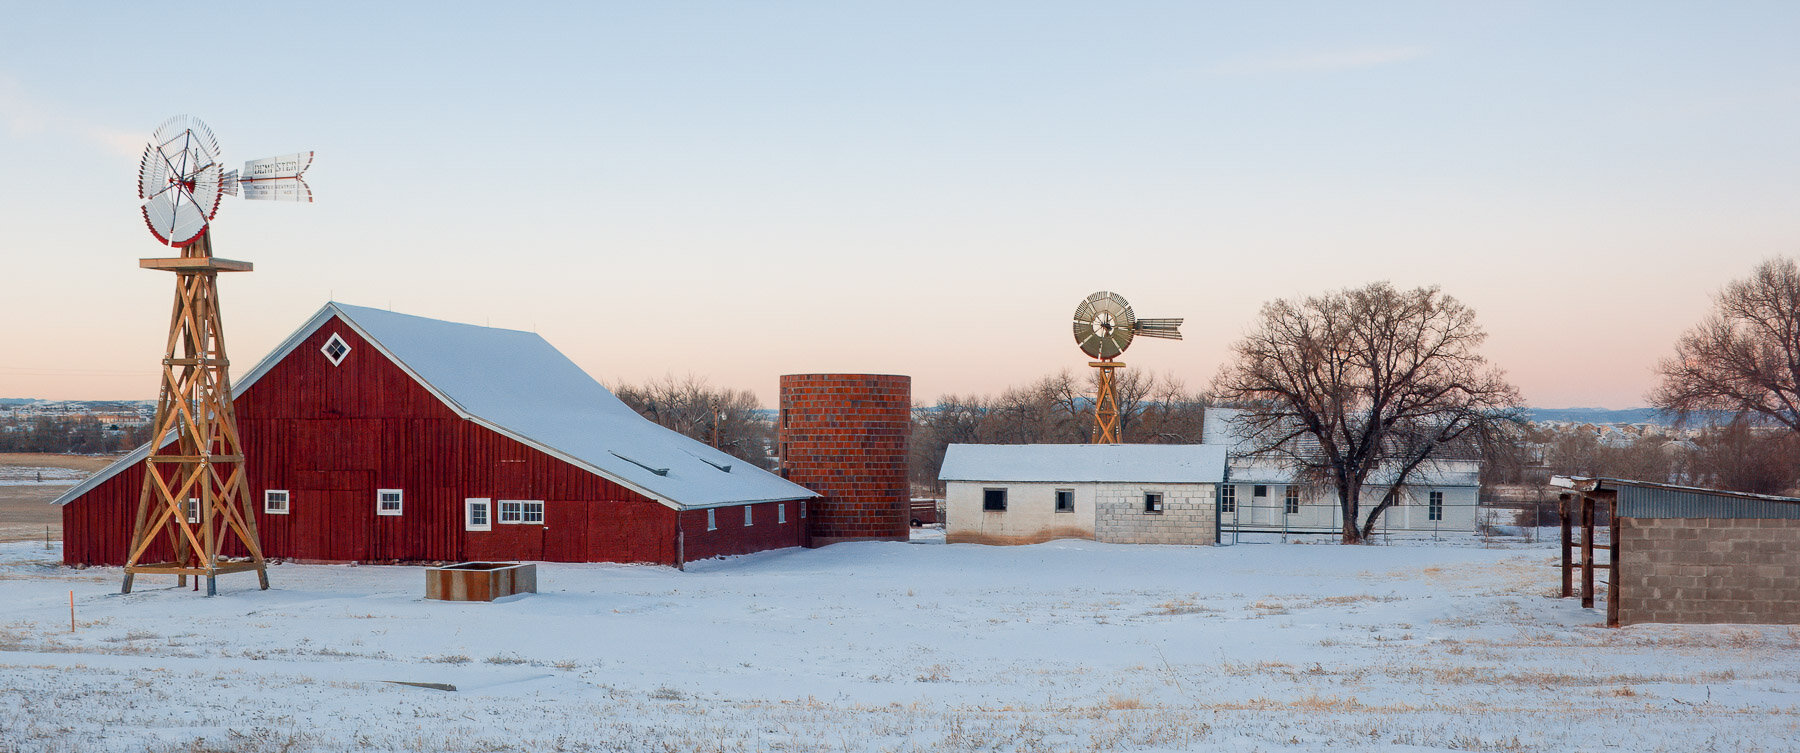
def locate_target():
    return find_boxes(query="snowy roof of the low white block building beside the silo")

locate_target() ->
[938,445,1226,483]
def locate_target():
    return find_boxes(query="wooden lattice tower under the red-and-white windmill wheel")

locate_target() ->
[121,231,268,596]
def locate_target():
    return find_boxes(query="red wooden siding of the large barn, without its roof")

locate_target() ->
[63,319,687,564]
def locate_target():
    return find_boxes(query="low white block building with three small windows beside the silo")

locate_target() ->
[938,445,1226,544]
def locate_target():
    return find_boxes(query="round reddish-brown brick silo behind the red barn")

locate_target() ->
[778,375,913,546]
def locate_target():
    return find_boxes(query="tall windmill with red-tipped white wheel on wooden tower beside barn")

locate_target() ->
[121,115,313,596]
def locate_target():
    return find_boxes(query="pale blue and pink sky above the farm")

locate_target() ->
[0,2,1800,407]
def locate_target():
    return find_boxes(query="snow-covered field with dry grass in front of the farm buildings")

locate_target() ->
[0,540,1800,753]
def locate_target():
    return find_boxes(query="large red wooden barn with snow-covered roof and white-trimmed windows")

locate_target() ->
[56,303,815,566]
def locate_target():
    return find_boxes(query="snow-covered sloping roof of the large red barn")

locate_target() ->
[56,303,817,508]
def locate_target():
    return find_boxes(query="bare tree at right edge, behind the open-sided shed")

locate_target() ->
[1651,258,1800,432]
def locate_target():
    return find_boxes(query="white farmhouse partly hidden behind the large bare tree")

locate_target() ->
[1202,407,1481,533]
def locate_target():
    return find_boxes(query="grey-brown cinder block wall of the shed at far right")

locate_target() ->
[1618,517,1800,625]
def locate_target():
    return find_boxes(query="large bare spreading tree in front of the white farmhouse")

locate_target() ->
[1213,283,1523,542]
